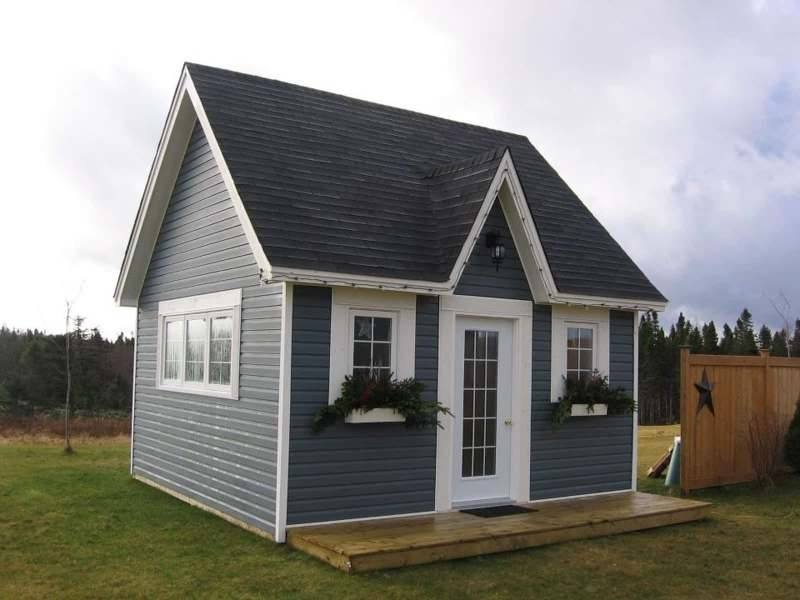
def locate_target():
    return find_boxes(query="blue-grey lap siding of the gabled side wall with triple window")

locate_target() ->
[132,126,283,534]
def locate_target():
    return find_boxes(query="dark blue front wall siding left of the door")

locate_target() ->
[287,286,438,525]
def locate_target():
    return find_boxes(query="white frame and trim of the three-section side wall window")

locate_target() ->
[156,289,242,400]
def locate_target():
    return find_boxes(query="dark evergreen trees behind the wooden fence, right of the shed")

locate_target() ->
[639,308,800,425]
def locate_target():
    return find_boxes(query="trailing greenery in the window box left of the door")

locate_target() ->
[311,372,452,433]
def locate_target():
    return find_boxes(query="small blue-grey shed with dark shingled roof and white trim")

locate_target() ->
[115,64,666,542]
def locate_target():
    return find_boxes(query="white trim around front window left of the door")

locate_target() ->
[328,287,417,404]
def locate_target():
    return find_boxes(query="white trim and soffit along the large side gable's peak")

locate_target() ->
[114,67,271,306]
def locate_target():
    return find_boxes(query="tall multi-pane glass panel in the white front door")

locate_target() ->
[461,330,499,477]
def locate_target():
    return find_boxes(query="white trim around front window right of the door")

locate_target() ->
[550,305,611,402]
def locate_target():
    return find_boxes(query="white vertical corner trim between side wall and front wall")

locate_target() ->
[275,283,294,543]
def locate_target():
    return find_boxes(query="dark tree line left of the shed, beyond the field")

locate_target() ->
[0,326,133,415]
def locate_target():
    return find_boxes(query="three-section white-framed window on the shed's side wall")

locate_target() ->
[159,309,238,395]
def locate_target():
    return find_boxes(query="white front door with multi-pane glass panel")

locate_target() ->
[453,317,513,504]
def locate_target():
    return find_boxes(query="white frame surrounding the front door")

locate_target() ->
[436,295,533,512]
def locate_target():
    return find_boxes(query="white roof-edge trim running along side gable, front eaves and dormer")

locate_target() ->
[114,66,666,311]
